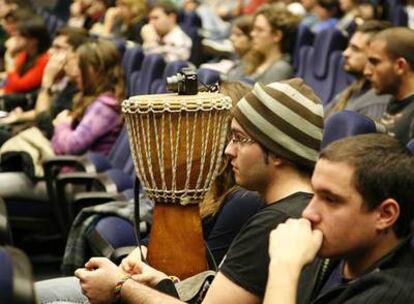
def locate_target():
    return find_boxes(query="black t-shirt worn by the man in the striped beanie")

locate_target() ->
[220,192,312,298]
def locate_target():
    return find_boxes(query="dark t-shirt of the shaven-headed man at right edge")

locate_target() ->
[381,95,414,144]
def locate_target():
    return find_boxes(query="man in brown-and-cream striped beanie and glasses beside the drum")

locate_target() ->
[70,79,323,304]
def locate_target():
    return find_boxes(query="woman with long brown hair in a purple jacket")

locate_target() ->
[0,41,124,200]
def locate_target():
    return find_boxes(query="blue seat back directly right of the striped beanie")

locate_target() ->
[321,110,386,148]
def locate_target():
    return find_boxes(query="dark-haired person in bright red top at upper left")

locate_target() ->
[3,17,51,94]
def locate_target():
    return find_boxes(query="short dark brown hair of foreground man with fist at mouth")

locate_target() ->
[320,133,414,237]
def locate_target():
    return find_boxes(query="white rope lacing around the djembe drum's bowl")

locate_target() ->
[122,94,231,205]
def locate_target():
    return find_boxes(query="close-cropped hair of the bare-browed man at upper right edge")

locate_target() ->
[372,27,414,71]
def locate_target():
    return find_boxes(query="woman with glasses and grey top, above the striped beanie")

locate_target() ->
[246,4,299,84]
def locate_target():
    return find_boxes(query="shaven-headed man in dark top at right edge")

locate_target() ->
[364,27,414,143]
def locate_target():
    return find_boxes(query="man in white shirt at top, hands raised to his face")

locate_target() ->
[141,2,192,62]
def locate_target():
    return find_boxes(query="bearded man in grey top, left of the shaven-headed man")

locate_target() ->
[325,20,391,119]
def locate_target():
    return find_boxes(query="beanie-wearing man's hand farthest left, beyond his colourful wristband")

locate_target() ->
[75,258,124,304]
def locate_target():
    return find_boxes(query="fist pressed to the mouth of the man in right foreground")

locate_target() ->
[269,218,323,270]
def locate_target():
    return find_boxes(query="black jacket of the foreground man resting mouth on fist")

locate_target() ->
[298,238,414,304]
